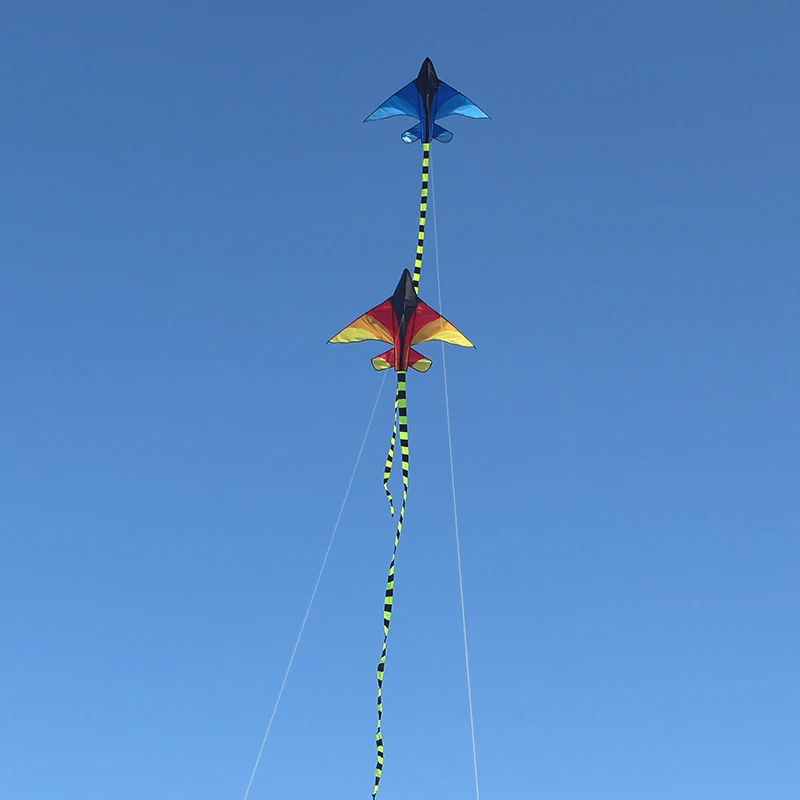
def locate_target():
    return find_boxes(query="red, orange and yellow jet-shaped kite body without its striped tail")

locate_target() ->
[330,270,475,372]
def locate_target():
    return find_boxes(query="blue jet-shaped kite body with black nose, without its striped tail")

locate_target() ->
[364,58,489,144]
